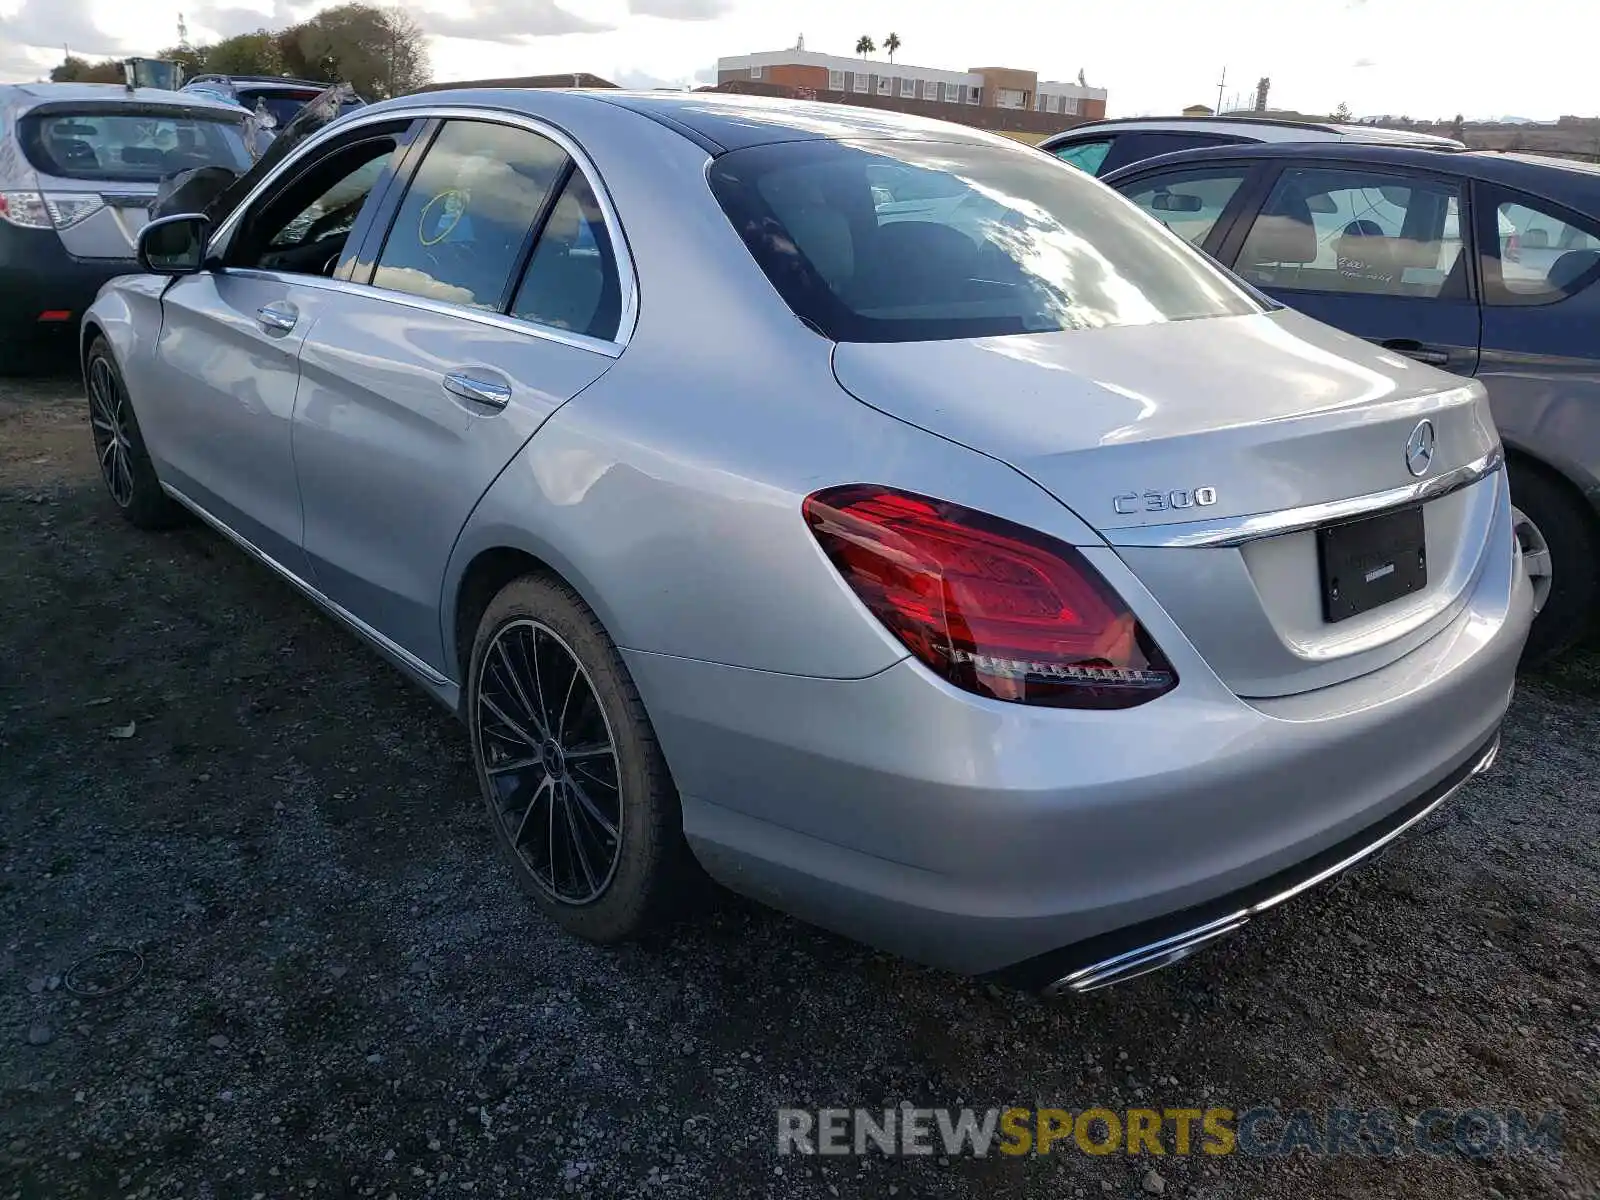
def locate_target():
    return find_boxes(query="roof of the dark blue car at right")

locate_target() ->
[1106,142,1600,214]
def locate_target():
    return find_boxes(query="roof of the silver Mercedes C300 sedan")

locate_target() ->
[374,88,1014,154]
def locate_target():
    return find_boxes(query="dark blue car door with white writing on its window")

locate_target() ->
[1218,160,1478,374]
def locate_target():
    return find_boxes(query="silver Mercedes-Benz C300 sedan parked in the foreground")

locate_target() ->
[83,91,1531,990]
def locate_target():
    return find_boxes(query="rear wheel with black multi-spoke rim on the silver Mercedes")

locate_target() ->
[464,574,693,942]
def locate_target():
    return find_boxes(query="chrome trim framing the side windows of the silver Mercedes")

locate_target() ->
[211,104,638,350]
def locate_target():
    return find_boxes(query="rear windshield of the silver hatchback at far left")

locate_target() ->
[19,106,250,182]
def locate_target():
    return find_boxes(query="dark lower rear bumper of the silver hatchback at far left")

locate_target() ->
[0,222,139,342]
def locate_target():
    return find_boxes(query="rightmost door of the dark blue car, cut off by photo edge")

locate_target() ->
[1474,184,1600,486]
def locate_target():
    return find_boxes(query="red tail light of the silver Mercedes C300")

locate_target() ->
[803,485,1178,709]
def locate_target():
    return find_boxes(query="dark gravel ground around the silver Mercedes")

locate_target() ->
[0,378,1600,1200]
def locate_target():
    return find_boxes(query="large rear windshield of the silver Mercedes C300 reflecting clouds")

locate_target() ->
[709,141,1262,342]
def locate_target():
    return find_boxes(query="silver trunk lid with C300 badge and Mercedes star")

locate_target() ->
[834,310,1502,696]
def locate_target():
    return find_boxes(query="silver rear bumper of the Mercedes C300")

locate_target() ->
[626,480,1531,986]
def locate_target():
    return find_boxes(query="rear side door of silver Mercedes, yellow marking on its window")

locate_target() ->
[294,115,632,670]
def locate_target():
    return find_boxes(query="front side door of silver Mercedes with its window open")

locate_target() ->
[141,122,425,576]
